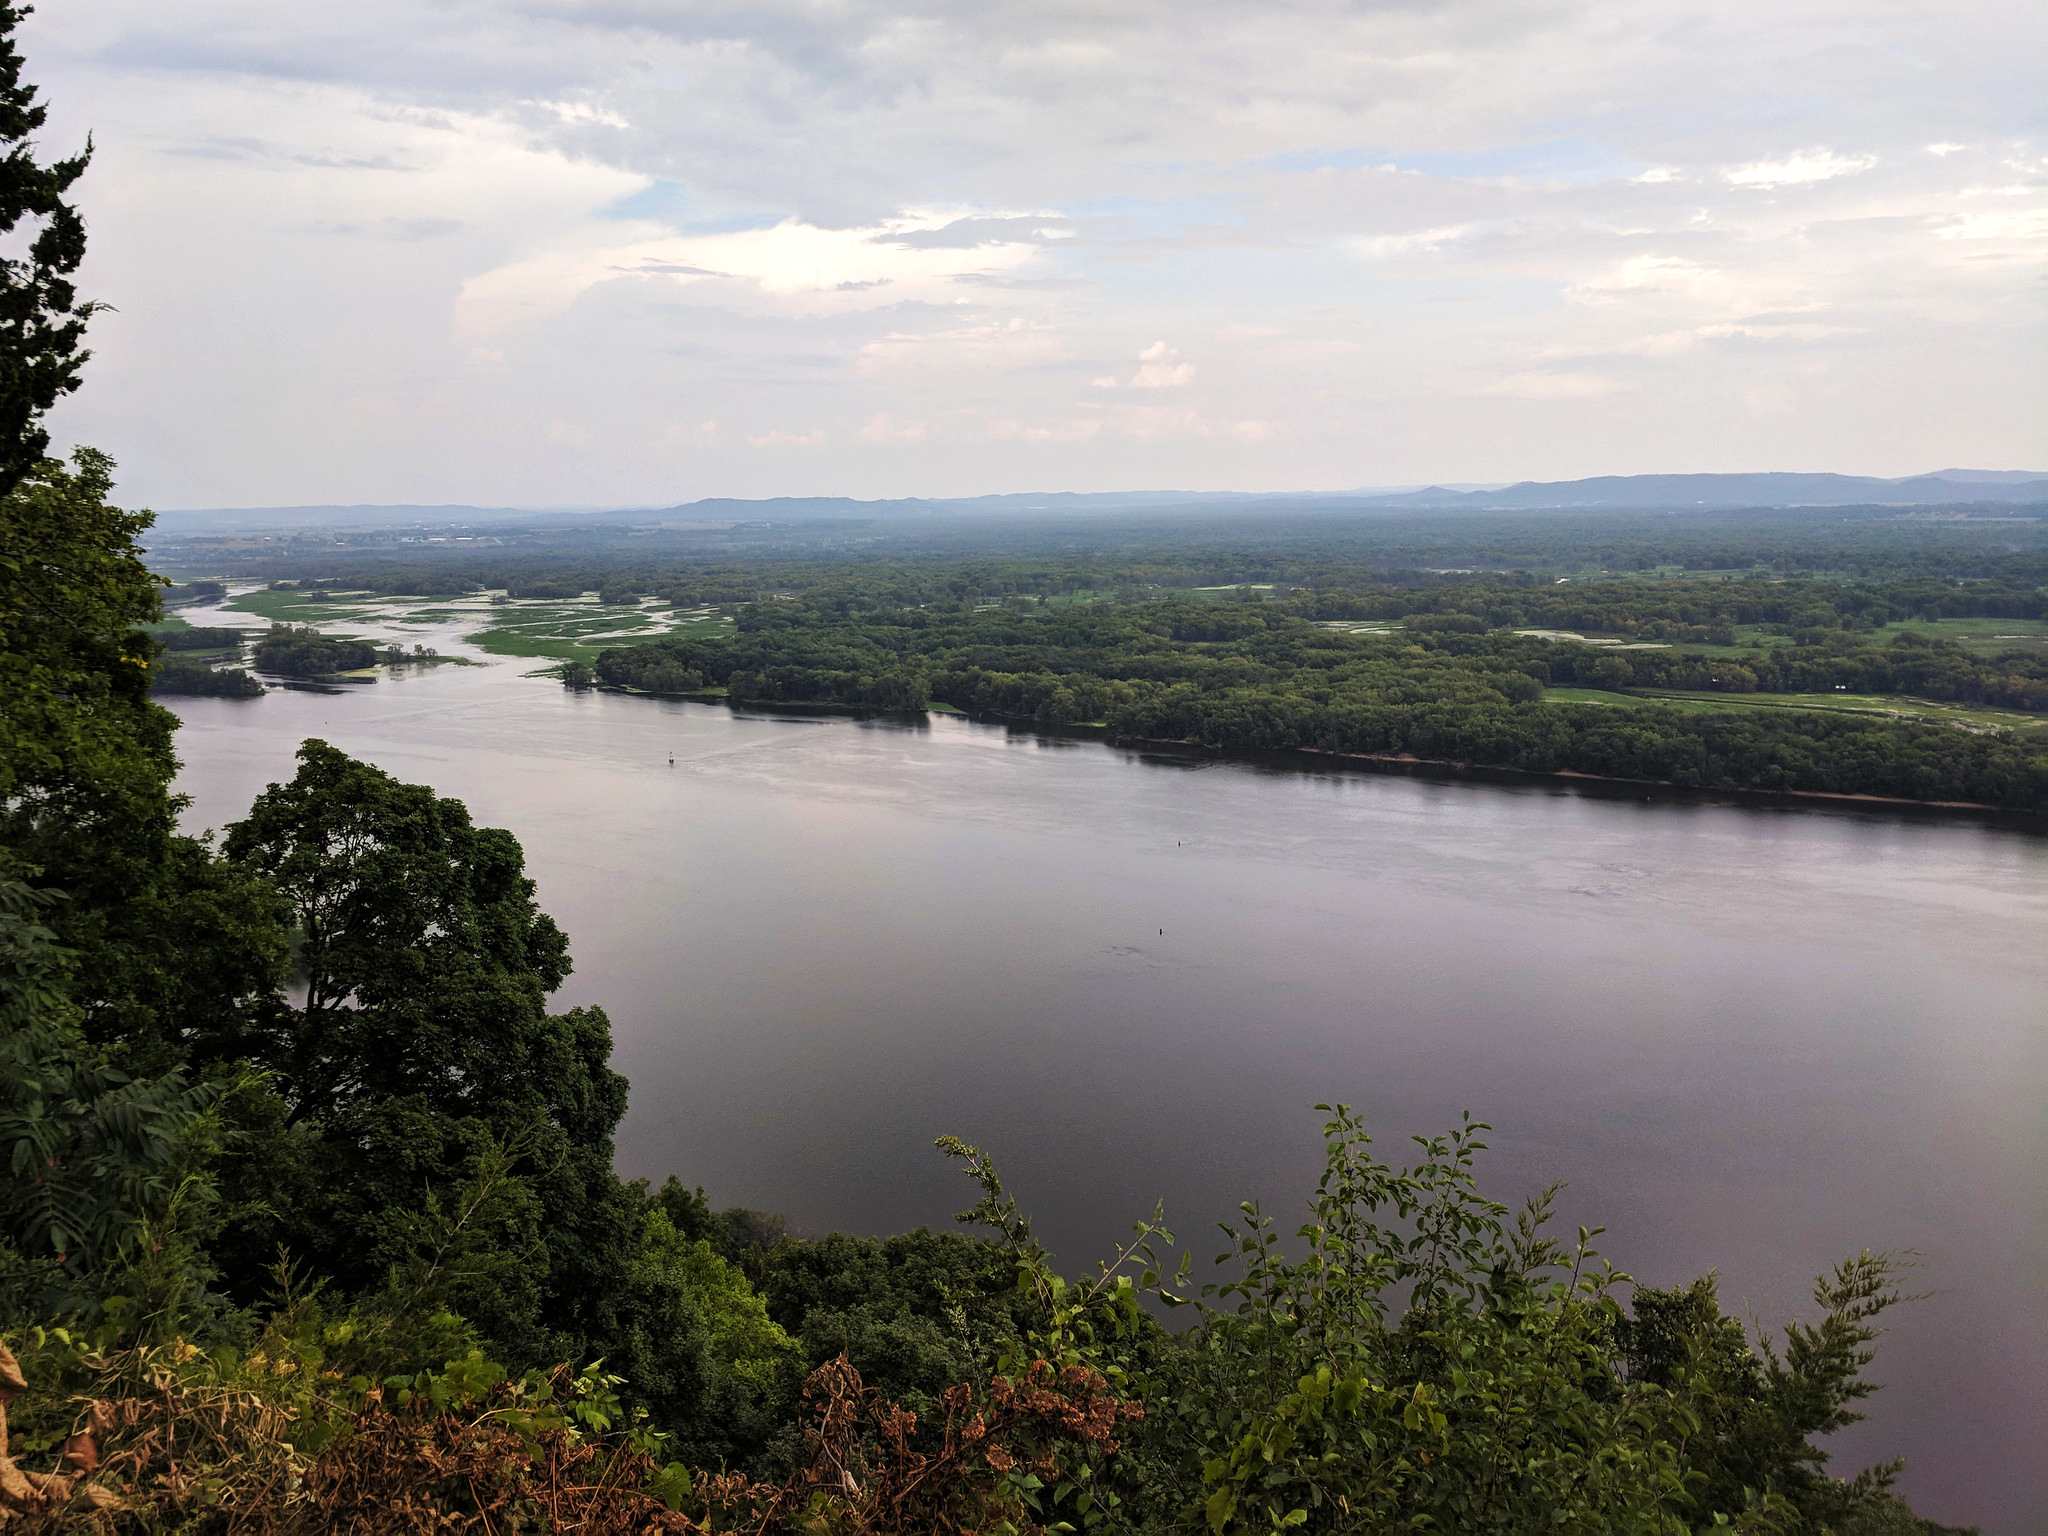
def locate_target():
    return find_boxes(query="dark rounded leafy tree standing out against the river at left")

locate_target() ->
[221,741,637,1350]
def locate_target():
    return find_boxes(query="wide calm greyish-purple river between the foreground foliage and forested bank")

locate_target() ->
[163,614,2048,1532]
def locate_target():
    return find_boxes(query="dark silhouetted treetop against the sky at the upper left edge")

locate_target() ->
[0,4,96,496]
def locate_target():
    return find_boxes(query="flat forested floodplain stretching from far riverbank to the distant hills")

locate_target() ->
[151,500,2048,813]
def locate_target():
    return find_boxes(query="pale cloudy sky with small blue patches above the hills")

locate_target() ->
[23,0,2048,508]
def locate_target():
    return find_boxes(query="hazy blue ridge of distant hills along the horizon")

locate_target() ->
[158,469,2048,535]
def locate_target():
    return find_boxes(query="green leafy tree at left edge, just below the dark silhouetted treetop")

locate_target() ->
[0,449,285,1069]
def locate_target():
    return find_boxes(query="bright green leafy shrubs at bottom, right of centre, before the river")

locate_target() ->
[942,1106,1966,1536]
